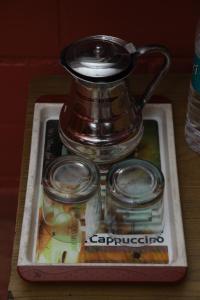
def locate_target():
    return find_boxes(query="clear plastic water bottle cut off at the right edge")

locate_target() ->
[185,21,200,153]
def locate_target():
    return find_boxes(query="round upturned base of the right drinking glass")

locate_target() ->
[107,159,164,208]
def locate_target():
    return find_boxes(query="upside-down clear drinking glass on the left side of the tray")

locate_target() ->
[43,155,101,243]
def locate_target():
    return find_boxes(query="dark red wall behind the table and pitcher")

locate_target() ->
[0,0,200,299]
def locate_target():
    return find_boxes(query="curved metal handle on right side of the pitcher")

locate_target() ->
[136,45,171,109]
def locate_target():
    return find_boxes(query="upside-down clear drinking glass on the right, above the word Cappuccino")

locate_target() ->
[105,159,164,234]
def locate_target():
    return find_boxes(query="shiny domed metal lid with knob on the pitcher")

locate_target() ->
[61,35,136,83]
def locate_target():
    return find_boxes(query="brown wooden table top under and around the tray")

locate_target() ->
[9,74,200,300]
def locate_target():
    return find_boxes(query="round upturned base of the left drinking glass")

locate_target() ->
[42,155,99,204]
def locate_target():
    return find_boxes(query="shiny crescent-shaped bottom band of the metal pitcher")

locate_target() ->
[58,123,144,165]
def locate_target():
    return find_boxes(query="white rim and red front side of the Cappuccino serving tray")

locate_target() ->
[18,103,187,282]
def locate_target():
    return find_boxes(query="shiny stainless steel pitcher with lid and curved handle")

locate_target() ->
[59,35,171,164]
